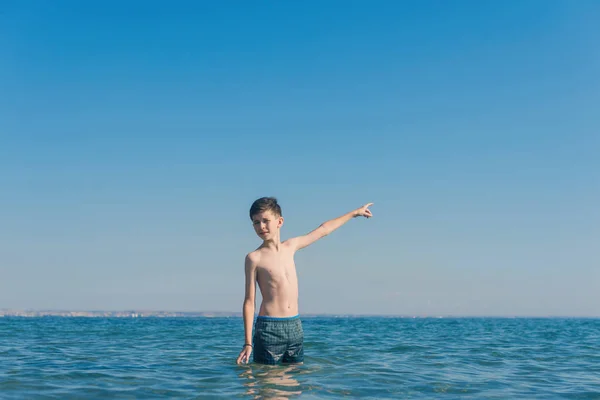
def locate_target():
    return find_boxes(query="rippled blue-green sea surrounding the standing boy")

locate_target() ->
[0,317,600,399]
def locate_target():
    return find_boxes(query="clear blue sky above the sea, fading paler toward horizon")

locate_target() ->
[0,0,600,316]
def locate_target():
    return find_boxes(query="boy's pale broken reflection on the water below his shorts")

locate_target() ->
[240,364,302,399]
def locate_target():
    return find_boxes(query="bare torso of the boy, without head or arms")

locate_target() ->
[256,242,298,317]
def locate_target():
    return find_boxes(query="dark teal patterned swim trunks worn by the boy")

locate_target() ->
[253,315,304,365]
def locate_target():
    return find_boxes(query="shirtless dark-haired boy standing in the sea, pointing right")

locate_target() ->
[237,197,373,364]
